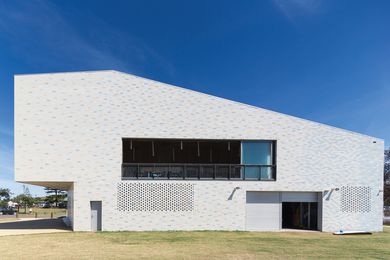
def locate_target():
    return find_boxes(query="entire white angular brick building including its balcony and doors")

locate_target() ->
[15,71,384,231]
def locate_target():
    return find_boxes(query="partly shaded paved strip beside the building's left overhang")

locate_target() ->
[0,219,71,236]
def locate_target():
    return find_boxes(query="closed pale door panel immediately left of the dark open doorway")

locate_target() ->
[246,191,281,231]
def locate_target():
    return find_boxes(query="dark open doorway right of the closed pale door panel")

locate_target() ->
[282,202,318,230]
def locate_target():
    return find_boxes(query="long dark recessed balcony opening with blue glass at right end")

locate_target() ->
[121,138,276,181]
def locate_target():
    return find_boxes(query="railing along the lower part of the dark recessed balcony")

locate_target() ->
[122,163,276,181]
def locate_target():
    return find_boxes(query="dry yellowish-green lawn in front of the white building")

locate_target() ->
[0,227,390,259]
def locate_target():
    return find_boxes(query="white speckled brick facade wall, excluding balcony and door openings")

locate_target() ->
[15,71,384,231]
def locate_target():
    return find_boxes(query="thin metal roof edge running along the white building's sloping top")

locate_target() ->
[14,69,384,144]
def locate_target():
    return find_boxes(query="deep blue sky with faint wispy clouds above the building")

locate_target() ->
[0,0,390,195]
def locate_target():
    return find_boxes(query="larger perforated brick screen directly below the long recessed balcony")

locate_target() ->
[118,182,194,211]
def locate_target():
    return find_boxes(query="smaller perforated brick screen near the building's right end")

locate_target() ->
[341,186,371,212]
